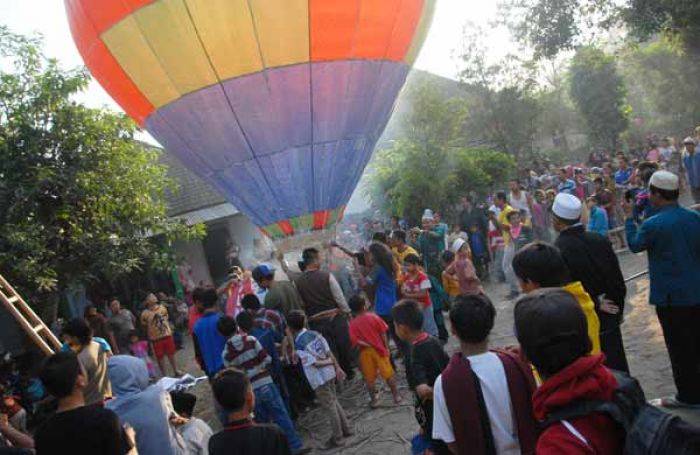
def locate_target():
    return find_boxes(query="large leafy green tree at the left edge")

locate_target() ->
[0,27,202,310]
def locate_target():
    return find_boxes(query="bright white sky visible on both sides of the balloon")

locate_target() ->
[0,0,509,117]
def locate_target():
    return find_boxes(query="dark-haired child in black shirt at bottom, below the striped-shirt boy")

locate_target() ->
[209,368,291,455]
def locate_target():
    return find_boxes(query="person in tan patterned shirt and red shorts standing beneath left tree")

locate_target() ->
[141,293,180,376]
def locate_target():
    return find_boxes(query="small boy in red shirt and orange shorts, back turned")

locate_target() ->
[348,295,401,408]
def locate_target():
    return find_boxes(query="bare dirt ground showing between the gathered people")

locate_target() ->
[172,248,675,455]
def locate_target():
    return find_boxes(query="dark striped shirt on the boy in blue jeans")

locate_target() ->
[221,334,272,390]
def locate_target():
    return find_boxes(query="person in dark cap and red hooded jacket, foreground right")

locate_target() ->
[515,288,624,455]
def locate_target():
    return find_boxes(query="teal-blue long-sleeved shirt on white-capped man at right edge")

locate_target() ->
[626,205,700,306]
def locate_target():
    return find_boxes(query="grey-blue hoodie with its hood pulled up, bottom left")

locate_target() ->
[105,355,186,455]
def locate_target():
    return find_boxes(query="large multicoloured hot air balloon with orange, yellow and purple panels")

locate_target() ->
[65,0,435,248]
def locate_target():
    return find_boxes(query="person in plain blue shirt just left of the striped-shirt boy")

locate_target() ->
[192,288,226,378]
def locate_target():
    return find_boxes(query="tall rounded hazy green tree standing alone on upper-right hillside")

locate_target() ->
[569,46,630,150]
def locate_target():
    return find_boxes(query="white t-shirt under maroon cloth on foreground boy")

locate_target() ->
[433,352,520,455]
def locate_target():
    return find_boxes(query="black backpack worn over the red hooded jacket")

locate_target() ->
[543,371,700,455]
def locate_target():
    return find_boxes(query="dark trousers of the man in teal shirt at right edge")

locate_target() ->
[656,306,700,404]
